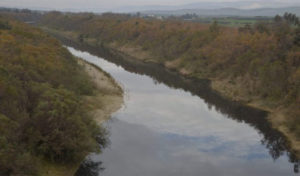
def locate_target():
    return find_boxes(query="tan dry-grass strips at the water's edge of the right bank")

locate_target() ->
[39,28,300,157]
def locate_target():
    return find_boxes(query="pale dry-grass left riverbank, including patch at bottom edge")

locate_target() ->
[40,58,123,176]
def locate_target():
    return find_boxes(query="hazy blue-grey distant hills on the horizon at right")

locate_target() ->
[142,7,300,17]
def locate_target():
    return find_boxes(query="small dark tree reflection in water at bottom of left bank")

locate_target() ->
[74,159,104,176]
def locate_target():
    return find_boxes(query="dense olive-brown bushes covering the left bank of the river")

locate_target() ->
[0,17,101,176]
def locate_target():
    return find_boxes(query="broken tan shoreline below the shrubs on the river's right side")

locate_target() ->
[43,28,300,158]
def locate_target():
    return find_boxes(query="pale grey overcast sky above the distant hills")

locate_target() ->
[0,0,300,11]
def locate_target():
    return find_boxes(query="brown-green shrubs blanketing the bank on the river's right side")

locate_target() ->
[35,12,300,139]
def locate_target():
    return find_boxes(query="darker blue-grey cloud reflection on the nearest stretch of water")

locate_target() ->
[96,119,292,176]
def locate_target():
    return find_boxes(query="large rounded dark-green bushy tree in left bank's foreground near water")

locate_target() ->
[23,88,100,161]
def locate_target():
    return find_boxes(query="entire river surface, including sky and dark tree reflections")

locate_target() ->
[68,47,298,176]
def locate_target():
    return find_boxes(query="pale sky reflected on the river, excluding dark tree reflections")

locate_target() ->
[70,49,298,176]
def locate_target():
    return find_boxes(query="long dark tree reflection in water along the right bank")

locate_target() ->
[61,39,299,173]
